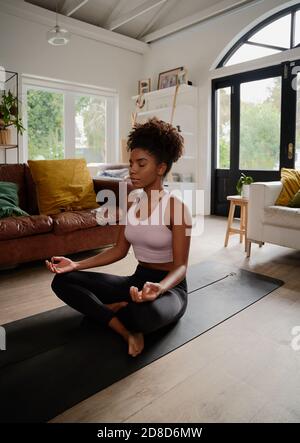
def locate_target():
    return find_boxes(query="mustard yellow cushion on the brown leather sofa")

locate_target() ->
[28,158,99,215]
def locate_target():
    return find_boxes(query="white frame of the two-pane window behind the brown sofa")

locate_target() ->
[20,75,119,163]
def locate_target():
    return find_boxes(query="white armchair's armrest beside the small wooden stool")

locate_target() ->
[248,181,282,241]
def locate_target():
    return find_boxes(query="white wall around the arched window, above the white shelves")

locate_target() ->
[143,0,296,214]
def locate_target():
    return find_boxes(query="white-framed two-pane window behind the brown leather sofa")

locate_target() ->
[23,79,118,163]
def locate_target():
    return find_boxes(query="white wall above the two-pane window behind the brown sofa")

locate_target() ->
[0,4,143,163]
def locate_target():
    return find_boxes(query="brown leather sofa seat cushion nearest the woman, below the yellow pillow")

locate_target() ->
[52,209,98,234]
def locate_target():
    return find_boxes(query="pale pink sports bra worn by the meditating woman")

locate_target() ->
[124,189,173,263]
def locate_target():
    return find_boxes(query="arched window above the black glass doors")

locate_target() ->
[218,3,300,68]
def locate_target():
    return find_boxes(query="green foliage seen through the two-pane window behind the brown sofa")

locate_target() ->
[27,89,106,162]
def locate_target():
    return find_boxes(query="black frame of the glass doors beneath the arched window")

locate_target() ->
[211,60,300,215]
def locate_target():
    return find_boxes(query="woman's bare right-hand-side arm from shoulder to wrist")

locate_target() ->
[160,196,192,294]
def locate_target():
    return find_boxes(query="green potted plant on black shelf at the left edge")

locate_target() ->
[0,91,25,145]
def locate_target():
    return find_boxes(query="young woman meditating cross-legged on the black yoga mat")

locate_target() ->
[46,118,192,357]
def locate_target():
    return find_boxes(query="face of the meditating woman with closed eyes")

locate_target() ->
[129,148,166,188]
